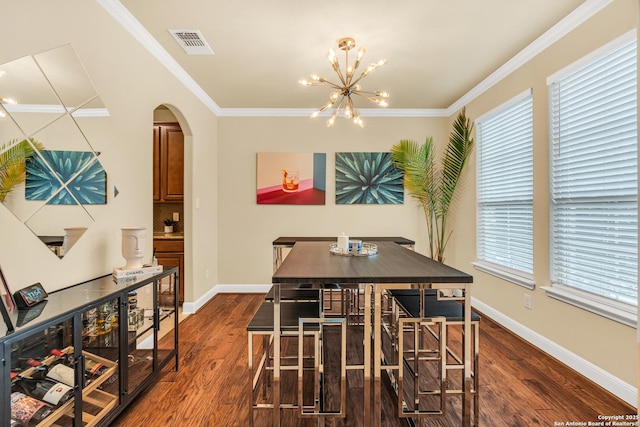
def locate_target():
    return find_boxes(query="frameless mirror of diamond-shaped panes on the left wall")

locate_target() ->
[0,44,117,258]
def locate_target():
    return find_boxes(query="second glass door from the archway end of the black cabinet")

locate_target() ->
[125,282,155,393]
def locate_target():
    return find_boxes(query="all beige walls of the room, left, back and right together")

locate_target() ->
[0,0,640,404]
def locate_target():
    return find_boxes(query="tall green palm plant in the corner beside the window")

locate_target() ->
[391,108,474,262]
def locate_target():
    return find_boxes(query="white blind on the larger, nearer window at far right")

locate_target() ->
[549,37,638,305]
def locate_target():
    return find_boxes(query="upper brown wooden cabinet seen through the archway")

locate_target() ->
[153,123,184,202]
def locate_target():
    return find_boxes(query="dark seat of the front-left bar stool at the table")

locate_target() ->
[247,301,320,332]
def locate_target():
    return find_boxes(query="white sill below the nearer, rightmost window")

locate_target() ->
[541,285,638,328]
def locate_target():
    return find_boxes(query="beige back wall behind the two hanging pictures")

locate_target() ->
[218,117,448,284]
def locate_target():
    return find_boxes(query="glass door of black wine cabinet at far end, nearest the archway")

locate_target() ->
[157,274,179,366]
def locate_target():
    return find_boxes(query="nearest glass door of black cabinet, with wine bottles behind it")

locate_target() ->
[4,317,77,426]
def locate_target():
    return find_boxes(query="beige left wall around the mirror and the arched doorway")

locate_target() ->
[0,0,217,308]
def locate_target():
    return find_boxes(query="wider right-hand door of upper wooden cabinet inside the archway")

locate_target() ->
[160,126,184,201]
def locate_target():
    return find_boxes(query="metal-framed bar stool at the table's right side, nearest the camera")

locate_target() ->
[392,290,481,425]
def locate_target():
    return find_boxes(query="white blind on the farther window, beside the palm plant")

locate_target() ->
[477,91,533,277]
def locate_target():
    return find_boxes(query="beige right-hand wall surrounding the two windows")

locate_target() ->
[450,0,638,387]
